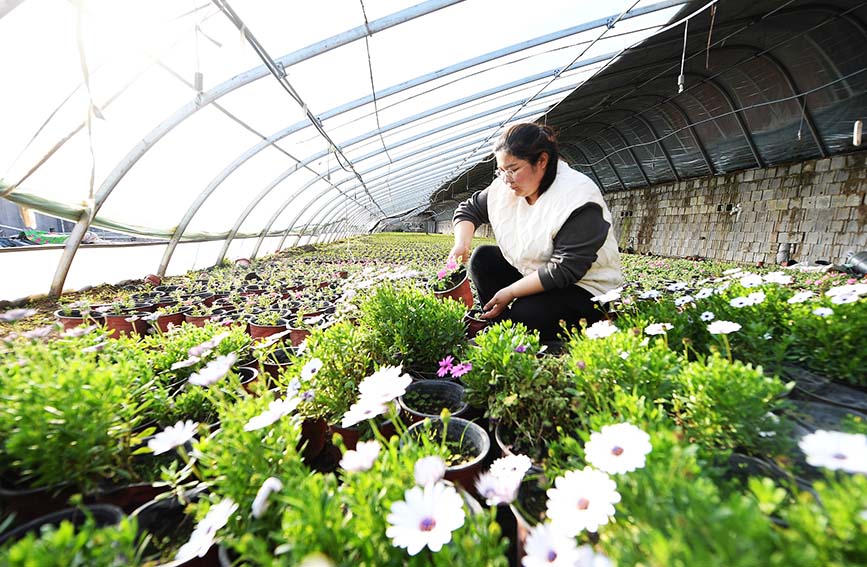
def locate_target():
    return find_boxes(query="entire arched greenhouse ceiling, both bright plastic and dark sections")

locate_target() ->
[0,0,865,300]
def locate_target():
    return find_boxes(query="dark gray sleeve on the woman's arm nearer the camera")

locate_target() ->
[538,203,611,291]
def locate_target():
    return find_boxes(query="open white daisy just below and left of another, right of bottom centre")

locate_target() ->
[548,467,620,537]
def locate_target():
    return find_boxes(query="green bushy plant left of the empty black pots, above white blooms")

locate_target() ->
[289,321,374,423]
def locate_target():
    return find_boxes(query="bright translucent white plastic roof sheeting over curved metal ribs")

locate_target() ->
[0,0,684,292]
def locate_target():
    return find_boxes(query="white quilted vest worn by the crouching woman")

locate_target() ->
[488,161,623,295]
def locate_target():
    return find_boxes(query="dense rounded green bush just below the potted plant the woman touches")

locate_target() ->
[361,284,466,372]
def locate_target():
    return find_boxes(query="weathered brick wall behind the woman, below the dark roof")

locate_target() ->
[605,152,867,264]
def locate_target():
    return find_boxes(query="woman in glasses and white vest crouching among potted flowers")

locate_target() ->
[449,124,623,340]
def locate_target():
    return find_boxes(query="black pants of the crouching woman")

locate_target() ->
[470,244,604,341]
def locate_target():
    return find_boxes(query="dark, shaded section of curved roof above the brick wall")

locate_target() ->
[434,0,867,204]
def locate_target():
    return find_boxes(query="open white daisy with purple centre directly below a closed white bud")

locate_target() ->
[385,483,466,555]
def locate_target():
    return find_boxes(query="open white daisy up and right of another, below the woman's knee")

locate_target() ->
[584,423,652,474]
